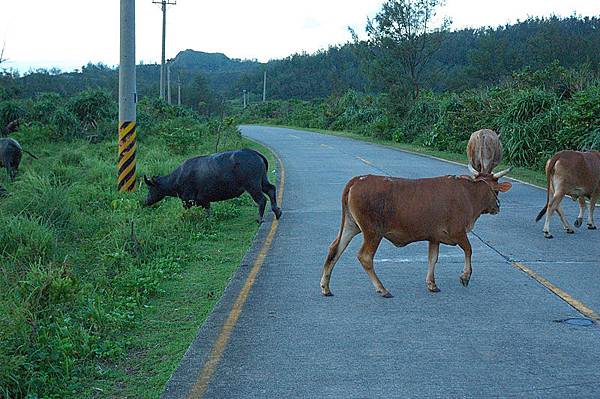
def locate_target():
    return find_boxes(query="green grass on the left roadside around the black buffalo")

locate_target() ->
[0,121,276,398]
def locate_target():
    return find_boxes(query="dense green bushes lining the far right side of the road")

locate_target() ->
[241,63,600,169]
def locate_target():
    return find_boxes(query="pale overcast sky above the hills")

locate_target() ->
[0,0,600,72]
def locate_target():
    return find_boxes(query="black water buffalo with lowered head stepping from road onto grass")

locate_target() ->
[144,148,281,223]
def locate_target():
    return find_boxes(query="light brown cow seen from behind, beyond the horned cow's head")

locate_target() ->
[467,129,502,173]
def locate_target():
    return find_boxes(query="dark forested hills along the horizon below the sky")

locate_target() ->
[0,16,600,104]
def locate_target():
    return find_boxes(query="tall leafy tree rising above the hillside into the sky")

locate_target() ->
[355,0,451,99]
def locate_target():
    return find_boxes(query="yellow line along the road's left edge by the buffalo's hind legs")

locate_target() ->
[188,151,285,399]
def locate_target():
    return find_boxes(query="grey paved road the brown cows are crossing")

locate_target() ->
[163,126,600,398]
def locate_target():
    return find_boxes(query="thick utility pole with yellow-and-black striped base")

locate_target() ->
[118,0,137,192]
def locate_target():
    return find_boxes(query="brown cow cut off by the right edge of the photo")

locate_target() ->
[535,150,600,238]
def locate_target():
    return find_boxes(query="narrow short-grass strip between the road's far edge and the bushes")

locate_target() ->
[260,124,546,188]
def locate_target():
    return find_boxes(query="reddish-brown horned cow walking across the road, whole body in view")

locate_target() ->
[321,164,511,298]
